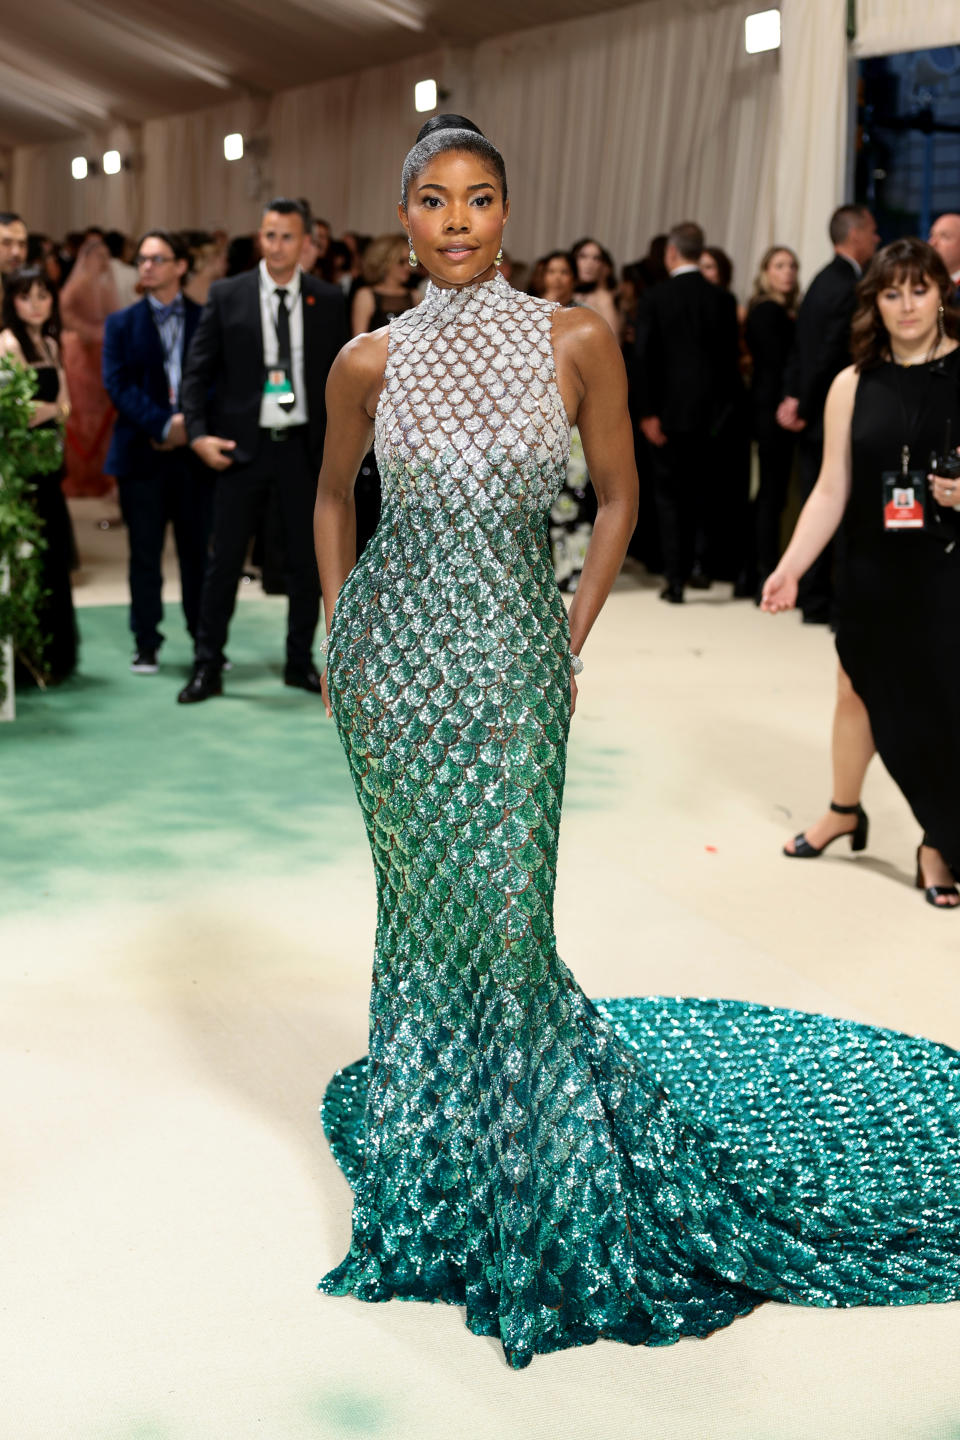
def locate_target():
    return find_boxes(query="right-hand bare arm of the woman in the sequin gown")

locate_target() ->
[554,307,639,673]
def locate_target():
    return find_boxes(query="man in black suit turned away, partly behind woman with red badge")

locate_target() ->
[777,204,879,625]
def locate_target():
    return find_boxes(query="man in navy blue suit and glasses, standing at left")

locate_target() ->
[104,230,213,675]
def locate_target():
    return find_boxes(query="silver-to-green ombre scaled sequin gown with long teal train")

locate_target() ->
[321,276,960,1368]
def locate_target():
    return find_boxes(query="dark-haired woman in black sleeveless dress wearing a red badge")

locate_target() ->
[763,239,960,909]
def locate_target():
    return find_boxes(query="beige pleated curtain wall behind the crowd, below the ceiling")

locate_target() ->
[12,0,788,294]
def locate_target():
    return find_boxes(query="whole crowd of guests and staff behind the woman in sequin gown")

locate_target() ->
[0,200,960,909]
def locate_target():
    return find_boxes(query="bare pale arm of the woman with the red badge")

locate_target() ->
[761,366,859,615]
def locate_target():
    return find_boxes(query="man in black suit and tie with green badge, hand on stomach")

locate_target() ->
[177,200,347,704]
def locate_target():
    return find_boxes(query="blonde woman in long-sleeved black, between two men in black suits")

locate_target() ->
[744,245,800,599]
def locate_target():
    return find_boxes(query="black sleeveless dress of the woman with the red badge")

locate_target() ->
[836,350,960,871]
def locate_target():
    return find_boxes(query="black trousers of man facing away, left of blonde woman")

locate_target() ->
[651,431,712,588]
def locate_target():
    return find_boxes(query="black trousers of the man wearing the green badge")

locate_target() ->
[197,425,320,671]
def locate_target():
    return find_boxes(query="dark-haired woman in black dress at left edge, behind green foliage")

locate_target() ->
[0,265,78,684]
